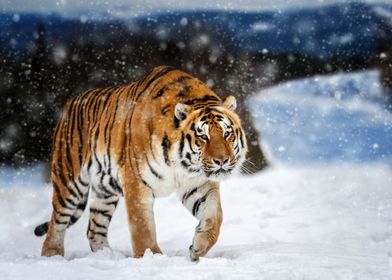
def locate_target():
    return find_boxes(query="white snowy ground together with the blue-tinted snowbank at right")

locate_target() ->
[0,72,392,280]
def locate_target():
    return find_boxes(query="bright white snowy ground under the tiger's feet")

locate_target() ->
[0,163,392,280]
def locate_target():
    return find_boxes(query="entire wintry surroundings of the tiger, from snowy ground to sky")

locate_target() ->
[0,0,392,280]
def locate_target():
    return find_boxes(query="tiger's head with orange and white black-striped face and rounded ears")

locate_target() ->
[175,96,247,181]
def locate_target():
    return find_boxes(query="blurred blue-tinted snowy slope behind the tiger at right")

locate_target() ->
[249,70,392,164]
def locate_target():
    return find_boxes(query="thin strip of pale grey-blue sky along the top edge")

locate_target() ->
[0,0,392,15]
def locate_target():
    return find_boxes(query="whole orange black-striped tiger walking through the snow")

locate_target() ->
[34,66,247,261]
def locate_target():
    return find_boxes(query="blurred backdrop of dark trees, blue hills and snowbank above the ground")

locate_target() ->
[0,0,392,171]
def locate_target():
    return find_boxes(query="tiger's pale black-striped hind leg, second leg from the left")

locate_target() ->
[87,175,122,252]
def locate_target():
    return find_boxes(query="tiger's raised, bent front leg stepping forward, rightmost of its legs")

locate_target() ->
[182,182,222,261]
